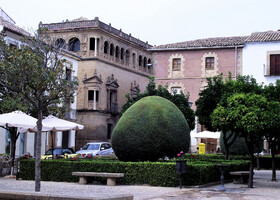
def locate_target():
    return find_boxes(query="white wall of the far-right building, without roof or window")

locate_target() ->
[242,42,280,85]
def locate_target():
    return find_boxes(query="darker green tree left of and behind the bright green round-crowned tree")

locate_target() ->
[196,73,262,160]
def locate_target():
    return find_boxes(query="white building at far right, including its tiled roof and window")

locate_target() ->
[242,31,280,85]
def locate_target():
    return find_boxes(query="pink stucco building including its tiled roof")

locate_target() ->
[150,37,246,113]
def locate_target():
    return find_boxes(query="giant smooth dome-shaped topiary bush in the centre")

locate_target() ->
[111,96,190,161]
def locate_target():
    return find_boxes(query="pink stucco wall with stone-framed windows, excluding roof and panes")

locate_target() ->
[153,48,242,109]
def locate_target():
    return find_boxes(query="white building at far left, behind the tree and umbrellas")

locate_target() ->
[0,8,78,156]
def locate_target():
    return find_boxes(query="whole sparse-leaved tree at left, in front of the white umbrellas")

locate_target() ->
[0,34,78,192]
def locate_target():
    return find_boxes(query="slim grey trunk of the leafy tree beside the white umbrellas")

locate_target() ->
[35,106,43,192]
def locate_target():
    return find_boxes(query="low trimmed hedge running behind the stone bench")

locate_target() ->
[20,159,249,187]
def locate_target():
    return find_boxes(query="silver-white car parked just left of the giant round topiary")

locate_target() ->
[76,142,114,158]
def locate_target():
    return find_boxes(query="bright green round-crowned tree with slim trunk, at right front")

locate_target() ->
[211,93,271,188]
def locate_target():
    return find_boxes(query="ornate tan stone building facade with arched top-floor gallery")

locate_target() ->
[40,19,153,150]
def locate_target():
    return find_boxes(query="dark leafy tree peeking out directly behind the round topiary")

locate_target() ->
[121,77,195,130]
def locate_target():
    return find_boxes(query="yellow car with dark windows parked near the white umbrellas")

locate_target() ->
[41,148,77,159]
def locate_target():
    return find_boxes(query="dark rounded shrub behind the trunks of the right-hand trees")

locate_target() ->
[220,132,263,155]
